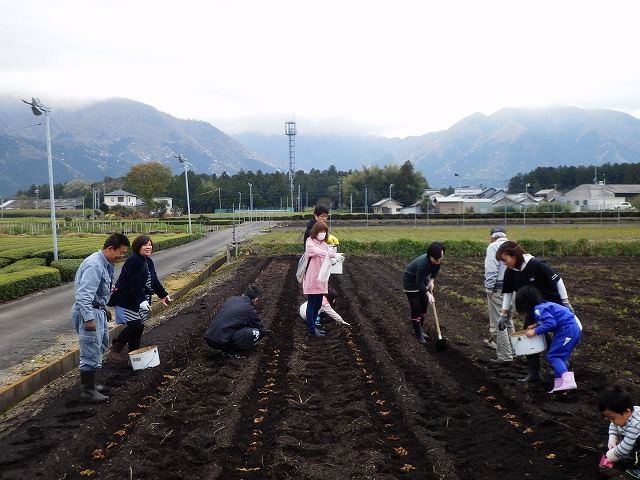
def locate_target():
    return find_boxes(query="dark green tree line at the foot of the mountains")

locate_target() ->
[16,161,640,214]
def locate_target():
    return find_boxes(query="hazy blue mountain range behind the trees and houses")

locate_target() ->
[0,97,640,198]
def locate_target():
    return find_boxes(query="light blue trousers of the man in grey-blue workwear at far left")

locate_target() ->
[71,304,109,372]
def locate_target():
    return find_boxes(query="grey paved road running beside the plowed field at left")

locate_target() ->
[0,221,273,370]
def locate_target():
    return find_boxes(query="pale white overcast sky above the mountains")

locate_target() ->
[0,0,640,137]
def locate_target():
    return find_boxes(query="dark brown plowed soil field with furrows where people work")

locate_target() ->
[0,256,640,480]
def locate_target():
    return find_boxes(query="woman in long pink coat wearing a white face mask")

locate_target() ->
[302,221,344,338]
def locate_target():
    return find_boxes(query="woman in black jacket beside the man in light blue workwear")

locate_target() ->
[109,235,171,363]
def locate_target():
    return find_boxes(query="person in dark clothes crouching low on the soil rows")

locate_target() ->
[204,286,269,358]
